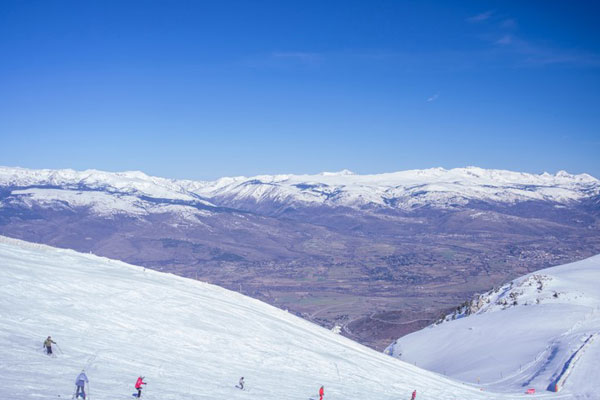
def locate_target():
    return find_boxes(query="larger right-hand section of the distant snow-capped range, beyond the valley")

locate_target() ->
[199,167,600,210]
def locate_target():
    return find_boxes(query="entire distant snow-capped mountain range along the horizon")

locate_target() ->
[0,167,600,210]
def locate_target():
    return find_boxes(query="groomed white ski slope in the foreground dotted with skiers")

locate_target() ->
[0,237,544,400]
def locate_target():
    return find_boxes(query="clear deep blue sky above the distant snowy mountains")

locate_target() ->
[0,0,600,179]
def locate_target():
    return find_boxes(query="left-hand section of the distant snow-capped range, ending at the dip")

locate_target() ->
[0,167,215,218]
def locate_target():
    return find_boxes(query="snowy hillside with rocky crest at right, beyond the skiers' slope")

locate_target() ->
[387,255,600,399]
